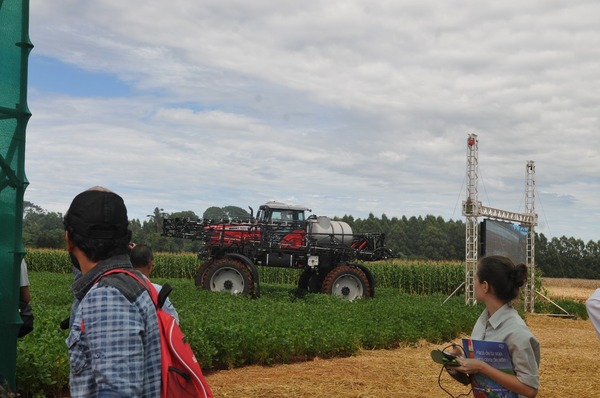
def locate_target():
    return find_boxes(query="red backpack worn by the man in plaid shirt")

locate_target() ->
[102,268,213,398]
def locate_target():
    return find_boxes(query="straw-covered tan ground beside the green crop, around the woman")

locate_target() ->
[207,315,600,398]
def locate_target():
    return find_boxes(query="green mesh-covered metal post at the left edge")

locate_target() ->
[0,0,33,391]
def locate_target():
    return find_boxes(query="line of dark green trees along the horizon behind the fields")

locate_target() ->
[23,201,600,279]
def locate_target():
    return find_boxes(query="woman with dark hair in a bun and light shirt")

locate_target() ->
[455,256,540,397]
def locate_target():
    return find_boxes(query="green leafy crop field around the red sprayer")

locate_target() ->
[17,250,585,397]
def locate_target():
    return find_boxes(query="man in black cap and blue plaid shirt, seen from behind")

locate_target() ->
[64,187,161,397]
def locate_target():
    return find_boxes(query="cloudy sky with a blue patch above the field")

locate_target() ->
[25,0,600,242]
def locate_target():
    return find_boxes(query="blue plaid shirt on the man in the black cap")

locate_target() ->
[66,255,161,398]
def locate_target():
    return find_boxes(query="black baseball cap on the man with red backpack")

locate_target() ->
[64,186,129,239]
